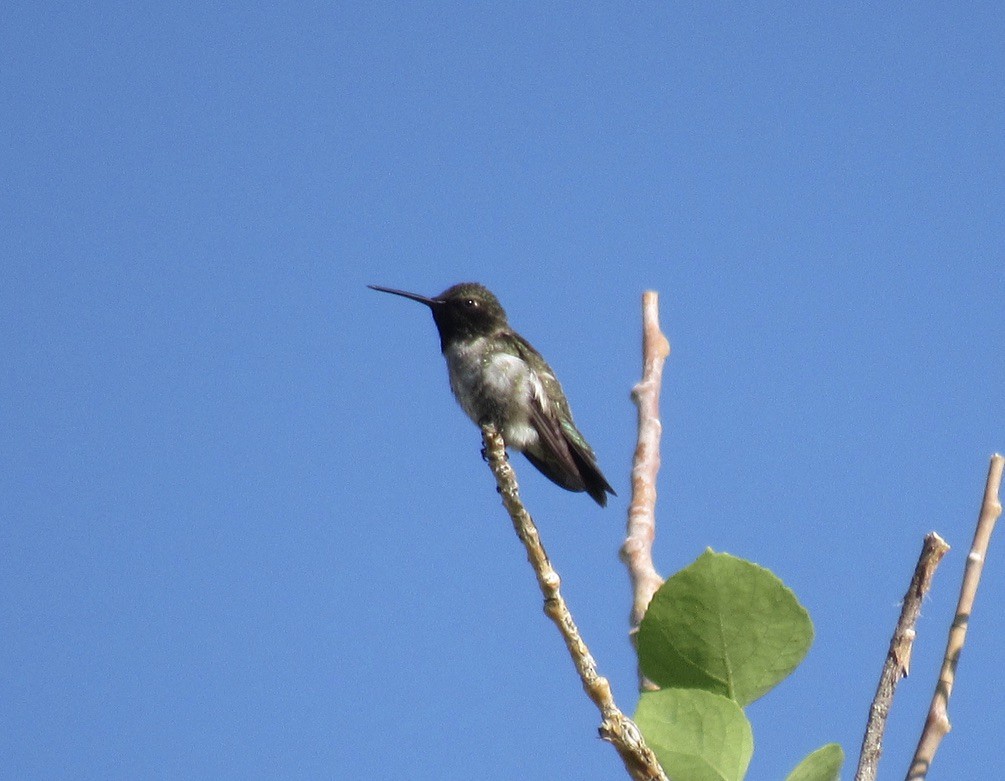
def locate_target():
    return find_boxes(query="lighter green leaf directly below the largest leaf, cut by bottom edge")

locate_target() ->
[635,689,754,781]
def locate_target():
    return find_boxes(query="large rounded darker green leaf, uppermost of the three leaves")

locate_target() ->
[638,550,813,706]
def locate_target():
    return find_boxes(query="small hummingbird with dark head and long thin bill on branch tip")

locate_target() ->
[369,282,616,507]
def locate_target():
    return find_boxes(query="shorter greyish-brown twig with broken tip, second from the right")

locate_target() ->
[855,532,949,781]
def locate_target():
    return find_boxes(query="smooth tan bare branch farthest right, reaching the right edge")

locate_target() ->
[908,453,1005,781]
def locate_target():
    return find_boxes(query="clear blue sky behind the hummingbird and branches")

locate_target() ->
[0,2,1005,780]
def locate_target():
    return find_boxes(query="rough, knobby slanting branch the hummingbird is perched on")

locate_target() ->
[481,423,667,781]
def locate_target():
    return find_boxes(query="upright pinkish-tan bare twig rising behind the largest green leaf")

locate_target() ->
[621,290,670,691]
